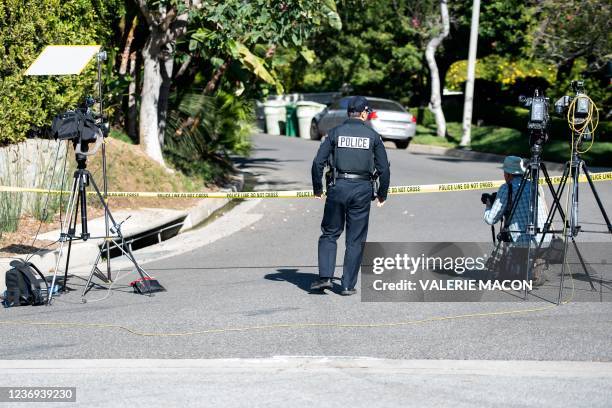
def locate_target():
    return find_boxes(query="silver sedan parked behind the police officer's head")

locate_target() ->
[310,96,416,149]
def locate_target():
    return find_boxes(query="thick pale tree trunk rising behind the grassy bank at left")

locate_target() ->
[139,35,165,166]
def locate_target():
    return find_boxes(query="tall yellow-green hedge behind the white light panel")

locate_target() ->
[0,0,123,146]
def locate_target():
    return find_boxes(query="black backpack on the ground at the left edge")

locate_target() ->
[4,260,49,307]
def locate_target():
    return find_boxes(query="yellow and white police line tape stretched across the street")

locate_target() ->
[0,171,612,199]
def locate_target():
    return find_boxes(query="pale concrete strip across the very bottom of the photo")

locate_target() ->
[0,356,612,408]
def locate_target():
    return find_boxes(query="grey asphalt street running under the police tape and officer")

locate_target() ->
[0,135,612,405]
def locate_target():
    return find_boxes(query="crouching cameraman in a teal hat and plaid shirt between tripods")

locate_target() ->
[481,156,550,286]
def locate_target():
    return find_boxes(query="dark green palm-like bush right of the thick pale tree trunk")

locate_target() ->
[164,92,254,181]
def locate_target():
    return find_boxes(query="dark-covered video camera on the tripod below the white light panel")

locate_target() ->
[51,96,110,156]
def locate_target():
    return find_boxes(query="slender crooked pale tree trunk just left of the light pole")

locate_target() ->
[425,0,450,137]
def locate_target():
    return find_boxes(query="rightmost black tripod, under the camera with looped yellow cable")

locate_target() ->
[540,135,612,304]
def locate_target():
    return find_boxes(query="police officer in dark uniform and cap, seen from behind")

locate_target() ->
[310,96,390,296]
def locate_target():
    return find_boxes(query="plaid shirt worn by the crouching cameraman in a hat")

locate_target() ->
[484,176,551,245]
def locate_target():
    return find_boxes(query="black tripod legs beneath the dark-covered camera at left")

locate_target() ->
[47,153,152,304]
